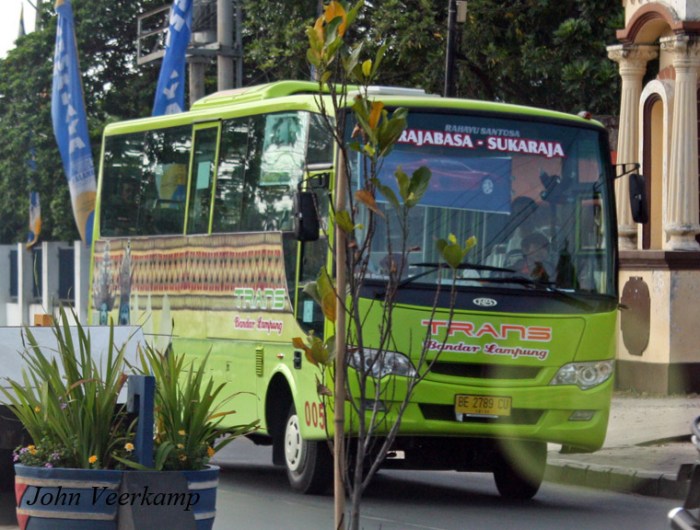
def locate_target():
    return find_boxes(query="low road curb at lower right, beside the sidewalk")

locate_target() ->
[544,461,689,500]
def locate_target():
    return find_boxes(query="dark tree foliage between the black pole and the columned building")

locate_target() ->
[457,0,624,114]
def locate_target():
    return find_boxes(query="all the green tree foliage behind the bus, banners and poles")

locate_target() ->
[0,0,623,243]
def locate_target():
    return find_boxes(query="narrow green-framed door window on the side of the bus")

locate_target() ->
[187,121,221,234]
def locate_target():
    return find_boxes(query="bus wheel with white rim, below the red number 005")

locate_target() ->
[284,405,333,494]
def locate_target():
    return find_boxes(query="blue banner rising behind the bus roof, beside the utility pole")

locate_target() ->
[153,0,193,116]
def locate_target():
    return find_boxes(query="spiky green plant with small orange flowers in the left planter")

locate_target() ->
[1,312,129,469]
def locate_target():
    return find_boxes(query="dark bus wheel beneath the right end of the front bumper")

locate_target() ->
[493,442,547,501]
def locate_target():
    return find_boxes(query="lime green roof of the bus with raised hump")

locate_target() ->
[105,81,602,135]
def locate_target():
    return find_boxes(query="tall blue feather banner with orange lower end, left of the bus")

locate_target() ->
[51,0,97,245]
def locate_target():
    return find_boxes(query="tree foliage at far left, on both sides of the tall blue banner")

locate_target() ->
[0,0,163,243]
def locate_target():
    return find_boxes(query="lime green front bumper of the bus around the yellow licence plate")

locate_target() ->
[330,374,613,452]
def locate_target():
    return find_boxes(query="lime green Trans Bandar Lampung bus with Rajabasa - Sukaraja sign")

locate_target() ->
[90,81,636,498]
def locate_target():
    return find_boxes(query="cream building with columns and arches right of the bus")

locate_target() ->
[608,0,700,393]
